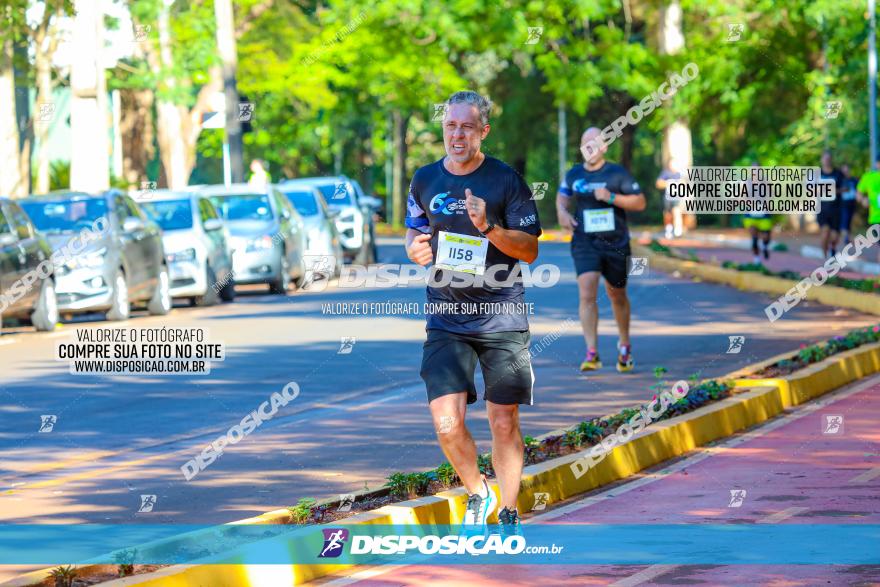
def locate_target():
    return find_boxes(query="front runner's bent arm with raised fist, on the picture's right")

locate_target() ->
[465,176,541,263]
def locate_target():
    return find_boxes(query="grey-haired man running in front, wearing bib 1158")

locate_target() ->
[406,92,541,534]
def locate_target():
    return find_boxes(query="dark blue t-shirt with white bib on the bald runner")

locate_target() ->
[559,161,642,249]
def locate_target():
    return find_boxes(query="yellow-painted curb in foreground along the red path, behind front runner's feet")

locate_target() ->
[63,343,880,587]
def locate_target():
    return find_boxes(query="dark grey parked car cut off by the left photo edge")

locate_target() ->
[0,198,58,331]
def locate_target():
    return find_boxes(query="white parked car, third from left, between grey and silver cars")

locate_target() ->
[135,190,235,306]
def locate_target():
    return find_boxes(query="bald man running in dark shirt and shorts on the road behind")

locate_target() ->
[556,127,646,373]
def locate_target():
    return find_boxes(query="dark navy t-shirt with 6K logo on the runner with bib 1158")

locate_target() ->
[406,156,541,334]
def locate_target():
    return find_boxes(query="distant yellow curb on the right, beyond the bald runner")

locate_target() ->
[632,243,880,315]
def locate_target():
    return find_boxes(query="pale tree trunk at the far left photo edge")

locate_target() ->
[0,38,27,197]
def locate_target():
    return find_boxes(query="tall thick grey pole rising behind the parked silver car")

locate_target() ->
[214,0,253,183]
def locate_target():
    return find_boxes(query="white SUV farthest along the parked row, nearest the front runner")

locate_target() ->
[281,175,381,265]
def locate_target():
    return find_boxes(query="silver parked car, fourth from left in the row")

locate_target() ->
[199,184,306,293]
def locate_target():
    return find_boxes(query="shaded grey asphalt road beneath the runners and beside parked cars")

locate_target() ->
[0,239,876,523]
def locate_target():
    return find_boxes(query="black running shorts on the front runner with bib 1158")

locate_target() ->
[421,329,535,405]
